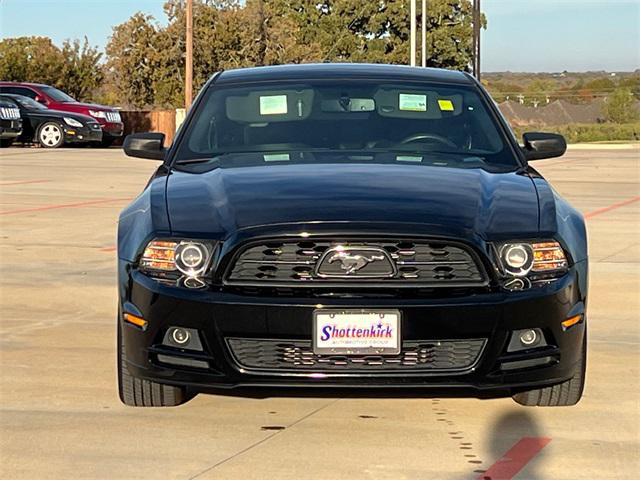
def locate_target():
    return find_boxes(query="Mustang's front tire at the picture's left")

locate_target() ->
[117,314,192,407]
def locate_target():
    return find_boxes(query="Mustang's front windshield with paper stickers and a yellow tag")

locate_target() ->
[176,80,519,169]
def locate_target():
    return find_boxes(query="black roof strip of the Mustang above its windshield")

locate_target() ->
[216,63,475,85]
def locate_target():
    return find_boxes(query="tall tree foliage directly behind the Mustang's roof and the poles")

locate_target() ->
[104,0,484,107]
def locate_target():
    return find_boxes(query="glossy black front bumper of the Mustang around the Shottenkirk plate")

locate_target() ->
[119,261,586,396]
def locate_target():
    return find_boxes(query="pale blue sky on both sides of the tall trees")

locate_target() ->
[0,0,640,72]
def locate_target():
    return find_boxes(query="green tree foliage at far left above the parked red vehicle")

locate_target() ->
[0,37,103,100]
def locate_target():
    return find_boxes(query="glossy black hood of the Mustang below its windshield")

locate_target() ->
[167,163,538,239]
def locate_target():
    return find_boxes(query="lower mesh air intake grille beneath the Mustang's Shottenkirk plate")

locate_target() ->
[227,338,485,373]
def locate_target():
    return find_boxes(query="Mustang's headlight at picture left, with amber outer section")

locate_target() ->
[140,240,213,277]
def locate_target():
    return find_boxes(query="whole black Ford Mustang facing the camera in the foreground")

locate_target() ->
[117,64,587,406]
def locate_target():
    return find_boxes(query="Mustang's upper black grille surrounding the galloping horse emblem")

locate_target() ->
[226,240,486,287]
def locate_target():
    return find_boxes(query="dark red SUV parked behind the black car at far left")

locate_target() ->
[0,82,124,147]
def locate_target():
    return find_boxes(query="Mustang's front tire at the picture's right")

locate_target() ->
[513,332,587,407]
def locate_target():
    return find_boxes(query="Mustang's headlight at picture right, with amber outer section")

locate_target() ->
[499,241,568,277]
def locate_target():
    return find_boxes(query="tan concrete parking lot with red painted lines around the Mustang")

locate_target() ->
[0,147,640,480]
